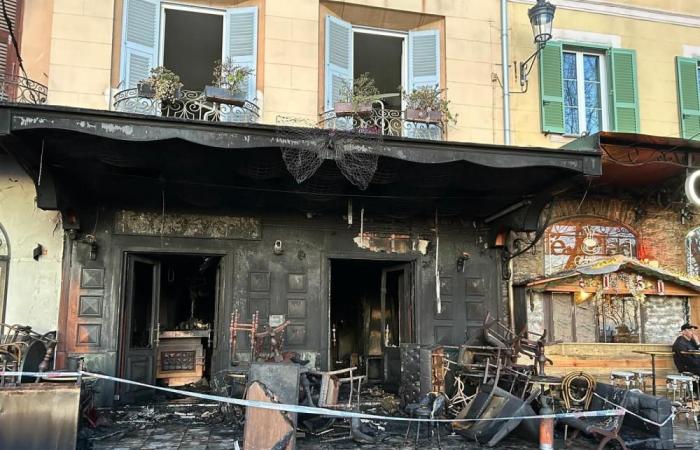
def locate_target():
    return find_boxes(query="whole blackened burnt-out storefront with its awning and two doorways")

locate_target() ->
[0,106,600,403]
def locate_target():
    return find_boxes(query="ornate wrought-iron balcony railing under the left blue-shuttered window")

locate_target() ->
[114,88,260,123]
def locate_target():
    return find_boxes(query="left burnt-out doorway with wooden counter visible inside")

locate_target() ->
[117,253,221,402]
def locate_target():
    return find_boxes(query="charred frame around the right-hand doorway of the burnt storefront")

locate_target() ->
[321,253,421,370]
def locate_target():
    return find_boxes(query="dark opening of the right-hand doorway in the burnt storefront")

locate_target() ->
[329,259,415,381]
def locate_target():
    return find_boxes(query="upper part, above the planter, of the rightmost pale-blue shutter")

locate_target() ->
[407,30,440,92]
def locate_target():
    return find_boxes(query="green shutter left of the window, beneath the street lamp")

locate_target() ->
[540,42,564,133]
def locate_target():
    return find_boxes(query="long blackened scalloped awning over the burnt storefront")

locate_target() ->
[0,104,601,234]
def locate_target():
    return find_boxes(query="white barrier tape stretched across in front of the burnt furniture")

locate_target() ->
[0,371,625,423]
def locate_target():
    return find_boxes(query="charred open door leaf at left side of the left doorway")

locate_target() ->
[120,255,160,402]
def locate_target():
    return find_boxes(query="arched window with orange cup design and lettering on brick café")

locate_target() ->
[544,217,637,275]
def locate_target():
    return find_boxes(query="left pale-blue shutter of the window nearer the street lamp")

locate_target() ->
[324,16,353,111]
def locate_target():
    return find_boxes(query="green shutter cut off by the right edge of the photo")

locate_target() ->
[676,57,700,139]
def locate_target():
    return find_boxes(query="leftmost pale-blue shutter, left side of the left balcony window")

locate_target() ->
[121,0,160,88]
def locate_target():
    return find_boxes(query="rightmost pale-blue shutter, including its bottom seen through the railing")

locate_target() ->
[404,30,442,140]
